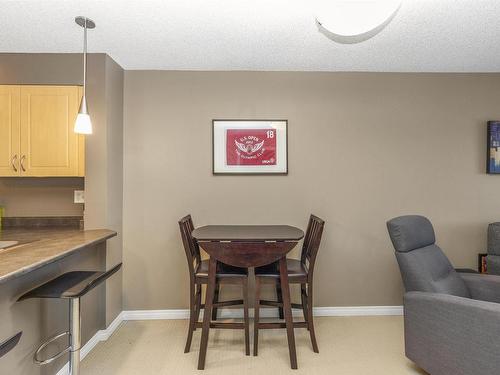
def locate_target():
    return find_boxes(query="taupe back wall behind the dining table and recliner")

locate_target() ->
[123,71,500,309]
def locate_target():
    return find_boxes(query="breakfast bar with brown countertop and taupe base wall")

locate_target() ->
[0,226,119,375]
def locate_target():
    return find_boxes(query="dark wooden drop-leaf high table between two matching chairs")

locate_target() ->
[192,225,304,370]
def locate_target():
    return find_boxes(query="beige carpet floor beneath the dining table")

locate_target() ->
[82,316,426,375]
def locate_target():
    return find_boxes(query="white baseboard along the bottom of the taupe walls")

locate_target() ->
[56,306,403,375]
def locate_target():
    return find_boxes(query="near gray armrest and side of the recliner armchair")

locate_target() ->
[404,292,500,375]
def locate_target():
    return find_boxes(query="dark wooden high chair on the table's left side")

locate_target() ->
[179,215,250,355]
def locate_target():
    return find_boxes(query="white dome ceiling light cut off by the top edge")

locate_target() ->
[316,0,401,43]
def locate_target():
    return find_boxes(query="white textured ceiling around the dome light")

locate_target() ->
[0,0,500,72]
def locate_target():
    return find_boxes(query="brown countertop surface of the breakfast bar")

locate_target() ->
[0,228,116,283]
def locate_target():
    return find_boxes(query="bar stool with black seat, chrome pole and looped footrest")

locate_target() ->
[18,263,122,375]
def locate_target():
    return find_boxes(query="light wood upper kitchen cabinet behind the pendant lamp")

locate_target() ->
[0,86,85,177]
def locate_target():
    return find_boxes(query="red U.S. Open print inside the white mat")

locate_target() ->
[226,129,276,165]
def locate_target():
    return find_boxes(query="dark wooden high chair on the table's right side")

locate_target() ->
[253,215,325,356]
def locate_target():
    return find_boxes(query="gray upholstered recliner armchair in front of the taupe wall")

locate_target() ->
[387,215,500,375]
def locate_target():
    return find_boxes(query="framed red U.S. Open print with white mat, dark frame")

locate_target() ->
[212,120,288,175]
